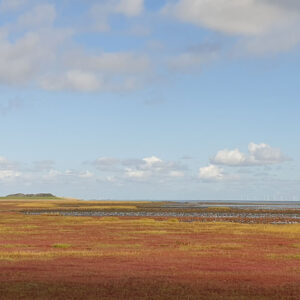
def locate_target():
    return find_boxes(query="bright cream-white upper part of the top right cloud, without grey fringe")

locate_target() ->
[163,0,299,35]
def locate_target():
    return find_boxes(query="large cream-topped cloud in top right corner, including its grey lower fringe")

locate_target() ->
[163,0,300,54]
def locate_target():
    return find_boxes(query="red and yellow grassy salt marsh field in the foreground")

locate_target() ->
[0,198,300,300]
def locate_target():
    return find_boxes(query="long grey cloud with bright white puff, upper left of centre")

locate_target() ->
[41,51,150,92]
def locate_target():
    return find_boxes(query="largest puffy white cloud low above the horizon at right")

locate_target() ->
[210,143,289,167]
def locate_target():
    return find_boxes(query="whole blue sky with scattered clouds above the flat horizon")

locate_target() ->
[0,0,300,201]
